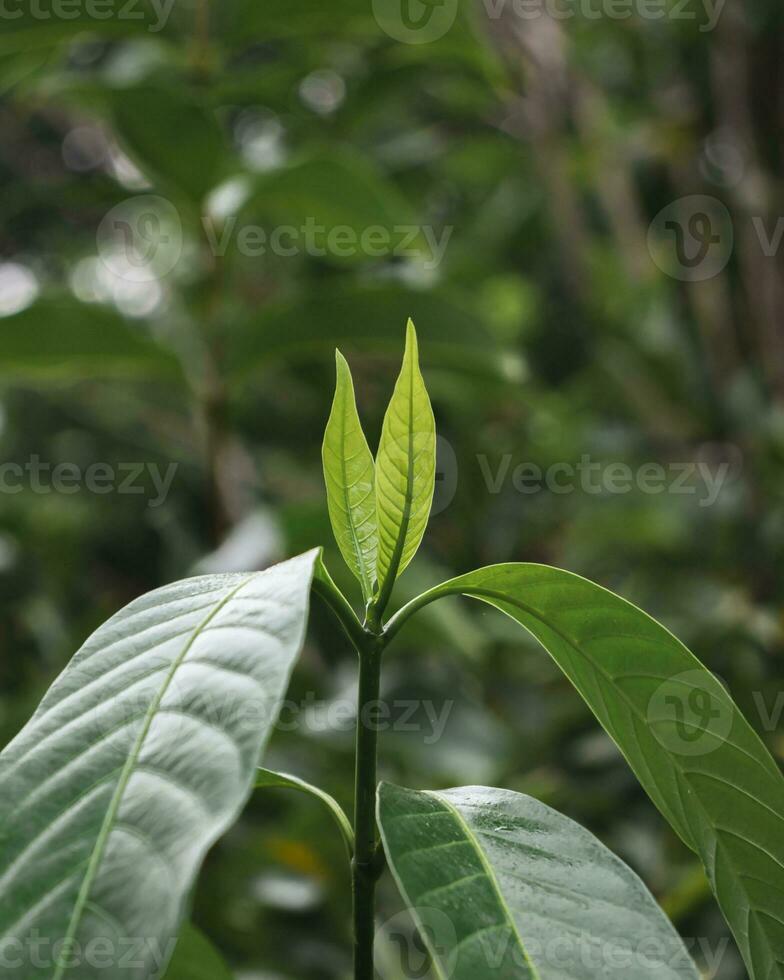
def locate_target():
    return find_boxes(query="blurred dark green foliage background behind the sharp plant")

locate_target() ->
[0,0,784,980]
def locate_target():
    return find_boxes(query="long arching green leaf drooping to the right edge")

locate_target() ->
[389,564,784,980]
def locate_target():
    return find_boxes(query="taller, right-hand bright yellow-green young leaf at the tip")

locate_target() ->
[376,320,436,609]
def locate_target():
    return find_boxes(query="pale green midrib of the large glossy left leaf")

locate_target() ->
[52,577,251,980]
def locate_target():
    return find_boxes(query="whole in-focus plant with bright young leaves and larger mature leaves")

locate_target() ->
[0,321,784,980]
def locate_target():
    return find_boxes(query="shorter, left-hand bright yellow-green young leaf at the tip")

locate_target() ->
[321,351,378,601]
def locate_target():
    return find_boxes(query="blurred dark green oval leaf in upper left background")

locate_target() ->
[111,84,228,203]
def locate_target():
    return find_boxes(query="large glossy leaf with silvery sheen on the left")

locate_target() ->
[0,551,317,980]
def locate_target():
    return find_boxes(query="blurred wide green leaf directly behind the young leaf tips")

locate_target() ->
[228,285,521,379]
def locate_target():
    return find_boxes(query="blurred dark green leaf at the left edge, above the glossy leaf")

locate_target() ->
[0,297,181,381]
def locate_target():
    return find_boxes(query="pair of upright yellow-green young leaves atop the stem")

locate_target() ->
[322,320,436,609]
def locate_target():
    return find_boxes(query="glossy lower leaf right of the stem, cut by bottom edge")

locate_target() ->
[378,784,699,980]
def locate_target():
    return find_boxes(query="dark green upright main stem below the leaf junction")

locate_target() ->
[352,634,383,980]
